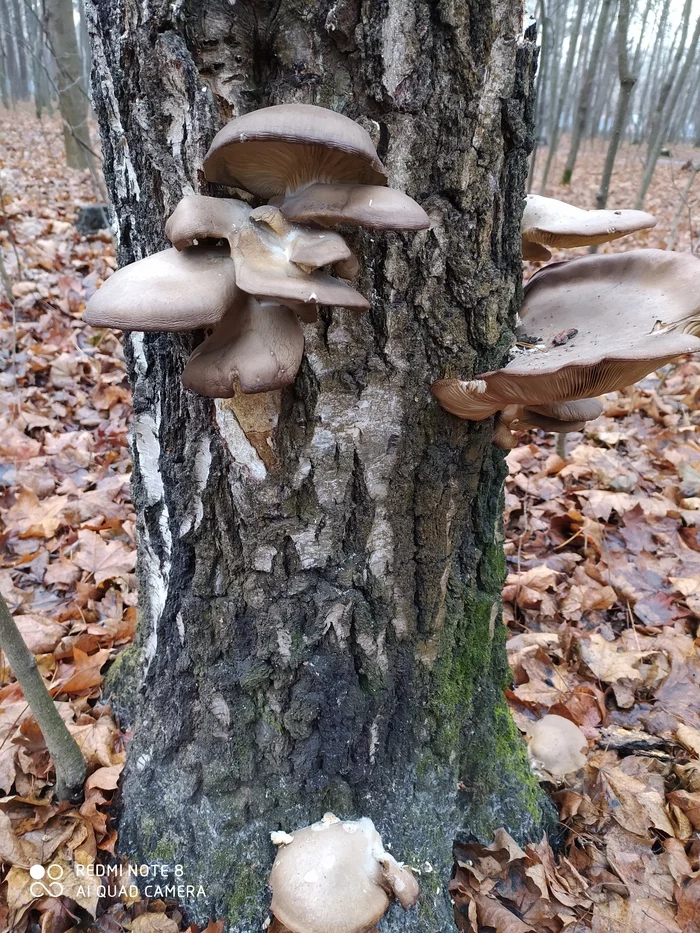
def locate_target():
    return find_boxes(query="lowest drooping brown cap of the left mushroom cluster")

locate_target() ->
[182,292,304,398]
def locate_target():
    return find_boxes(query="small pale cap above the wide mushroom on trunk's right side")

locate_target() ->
[521,194,656,251]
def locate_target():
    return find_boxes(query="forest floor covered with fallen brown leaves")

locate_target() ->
[0,110,700,933]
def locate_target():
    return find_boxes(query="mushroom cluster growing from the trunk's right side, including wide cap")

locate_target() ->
[432,195,700,449]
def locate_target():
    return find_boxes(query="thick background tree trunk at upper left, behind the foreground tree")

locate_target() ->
[44,0,92,169]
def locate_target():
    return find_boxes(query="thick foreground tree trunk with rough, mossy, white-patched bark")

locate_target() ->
[86,0,543,931]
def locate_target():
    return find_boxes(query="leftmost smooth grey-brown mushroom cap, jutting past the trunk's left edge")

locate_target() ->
[83,247,236,331]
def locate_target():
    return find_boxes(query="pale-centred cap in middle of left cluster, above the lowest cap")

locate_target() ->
[231,223,369,311]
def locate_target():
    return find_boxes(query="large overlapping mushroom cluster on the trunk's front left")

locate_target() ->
[84,104,430,398]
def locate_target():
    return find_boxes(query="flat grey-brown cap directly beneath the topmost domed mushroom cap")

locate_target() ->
[280,184,430,230]
